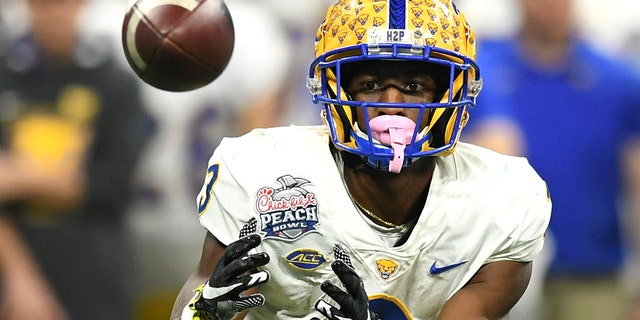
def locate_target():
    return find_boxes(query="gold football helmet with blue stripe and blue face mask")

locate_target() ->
[307,0,482,172]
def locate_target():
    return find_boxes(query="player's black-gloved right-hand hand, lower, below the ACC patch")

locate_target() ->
[312,260,379,320]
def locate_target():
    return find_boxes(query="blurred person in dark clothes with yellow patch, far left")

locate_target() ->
[0,0,146,320]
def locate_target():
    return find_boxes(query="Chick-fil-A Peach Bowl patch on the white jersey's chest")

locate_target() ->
[256,175,318,240]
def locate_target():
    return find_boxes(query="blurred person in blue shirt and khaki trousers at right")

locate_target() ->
[463,0,640,320]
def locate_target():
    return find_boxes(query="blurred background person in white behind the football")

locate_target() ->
[129,0,298,320]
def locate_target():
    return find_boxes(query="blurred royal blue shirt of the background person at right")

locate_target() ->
[469,39,640,276]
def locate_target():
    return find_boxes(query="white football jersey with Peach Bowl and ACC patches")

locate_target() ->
[198,126,551,320]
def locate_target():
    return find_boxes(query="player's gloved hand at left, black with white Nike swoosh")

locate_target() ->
[195,234,269,319]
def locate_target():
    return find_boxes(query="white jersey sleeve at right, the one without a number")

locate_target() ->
[487,158,551,262]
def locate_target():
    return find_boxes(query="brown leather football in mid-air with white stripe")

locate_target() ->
[122,0,235,92]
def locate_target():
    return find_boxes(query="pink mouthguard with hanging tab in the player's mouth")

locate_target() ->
[369,115,416,173]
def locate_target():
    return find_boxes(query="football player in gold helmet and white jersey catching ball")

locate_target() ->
[172,0,551,320]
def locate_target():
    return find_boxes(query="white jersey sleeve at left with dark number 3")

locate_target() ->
[197,138,252,245]
